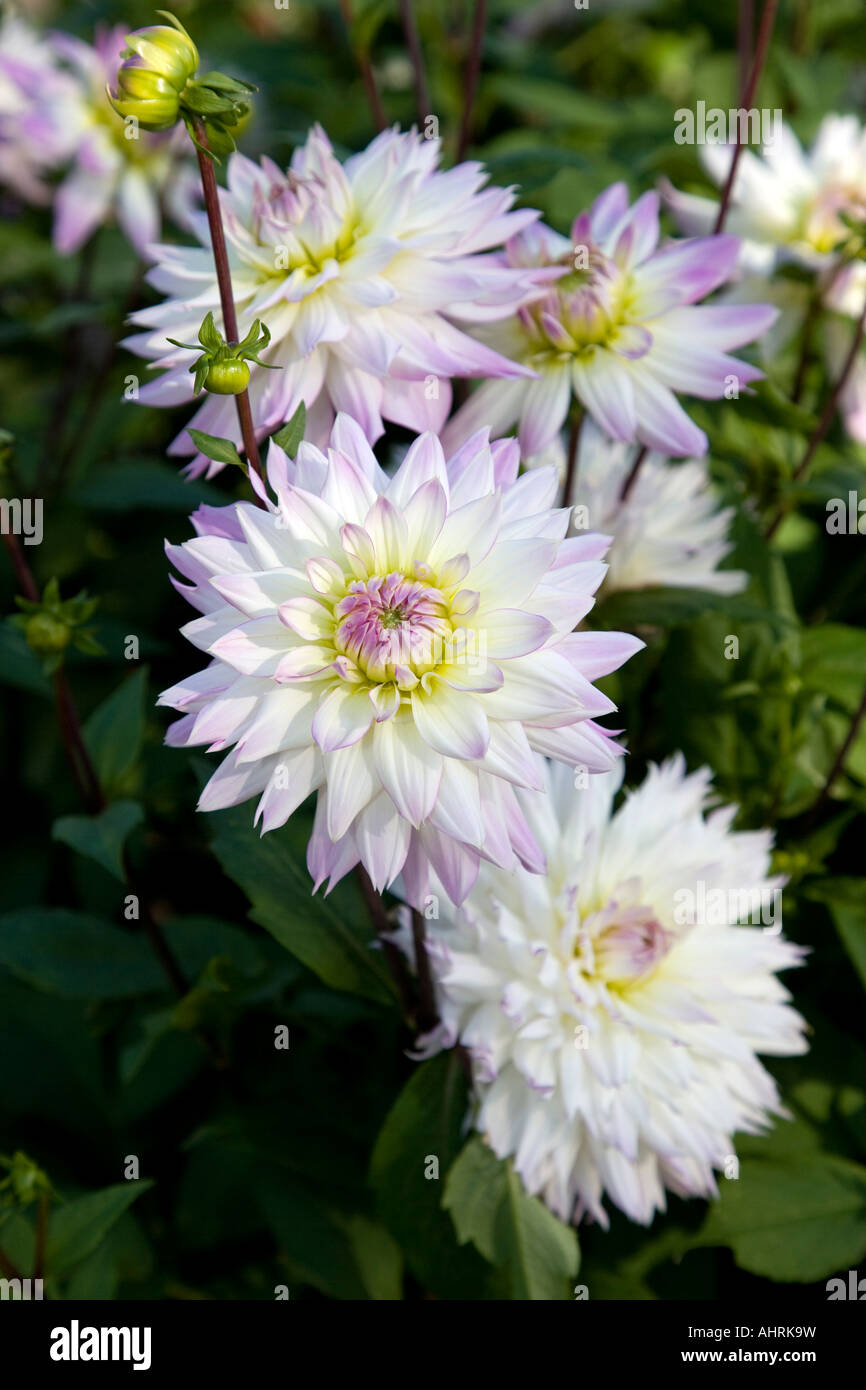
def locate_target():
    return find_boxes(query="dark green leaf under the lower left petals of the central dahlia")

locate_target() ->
[213,806,396,1002]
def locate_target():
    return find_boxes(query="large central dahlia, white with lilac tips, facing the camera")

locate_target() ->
[161,416,642,902]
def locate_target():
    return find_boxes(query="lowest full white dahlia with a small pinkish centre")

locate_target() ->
[400,755,806,1226]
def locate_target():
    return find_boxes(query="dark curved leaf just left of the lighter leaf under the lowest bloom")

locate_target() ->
[370,1052,497,1298]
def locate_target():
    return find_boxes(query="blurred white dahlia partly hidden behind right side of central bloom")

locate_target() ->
[532,420,748,594]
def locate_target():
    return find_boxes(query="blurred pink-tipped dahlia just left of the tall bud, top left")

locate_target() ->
[49,25,199,256]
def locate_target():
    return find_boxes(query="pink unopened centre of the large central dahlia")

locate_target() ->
[335,571,452,684]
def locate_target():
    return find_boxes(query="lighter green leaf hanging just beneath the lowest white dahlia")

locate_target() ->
[442,1136,580,1301]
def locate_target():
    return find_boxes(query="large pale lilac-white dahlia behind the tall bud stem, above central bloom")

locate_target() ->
[125,126,539,474]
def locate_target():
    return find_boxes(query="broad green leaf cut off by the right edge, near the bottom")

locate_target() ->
[699,1150,866,1284]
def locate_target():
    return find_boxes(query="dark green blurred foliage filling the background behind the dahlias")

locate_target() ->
[0,0,866,1300]
